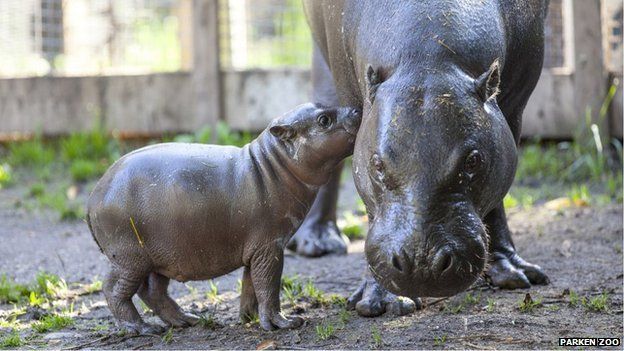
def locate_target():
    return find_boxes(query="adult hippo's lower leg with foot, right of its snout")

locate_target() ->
[484,204,550,289]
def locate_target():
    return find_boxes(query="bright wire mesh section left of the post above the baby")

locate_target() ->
[0,0,182,77]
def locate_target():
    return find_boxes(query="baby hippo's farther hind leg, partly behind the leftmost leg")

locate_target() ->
[139,273,199,327]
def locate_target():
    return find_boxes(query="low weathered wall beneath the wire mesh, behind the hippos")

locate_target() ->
[0,69,622,138]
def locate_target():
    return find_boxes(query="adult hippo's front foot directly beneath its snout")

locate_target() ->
[347,276,422,317]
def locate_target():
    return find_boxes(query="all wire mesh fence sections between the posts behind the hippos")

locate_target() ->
[0,0,622,77]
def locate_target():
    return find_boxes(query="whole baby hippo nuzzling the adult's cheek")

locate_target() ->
[87,104,361,333]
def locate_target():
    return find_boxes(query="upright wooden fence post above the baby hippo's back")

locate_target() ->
[191,0,221,132]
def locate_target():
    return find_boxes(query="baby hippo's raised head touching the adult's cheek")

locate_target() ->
[269,103,362,185]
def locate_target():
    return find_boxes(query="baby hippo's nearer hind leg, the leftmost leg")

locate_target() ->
[103,268,163,334]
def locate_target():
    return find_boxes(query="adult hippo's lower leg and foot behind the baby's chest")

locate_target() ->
[287,164,349,257]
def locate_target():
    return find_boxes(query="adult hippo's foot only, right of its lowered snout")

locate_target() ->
[486,251,550,289]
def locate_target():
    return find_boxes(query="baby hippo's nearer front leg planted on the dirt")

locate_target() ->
[251,248,303,330]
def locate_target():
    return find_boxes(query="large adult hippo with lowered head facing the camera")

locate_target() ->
[293,0,548,316]
